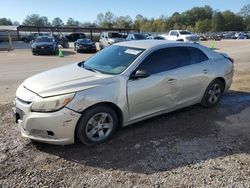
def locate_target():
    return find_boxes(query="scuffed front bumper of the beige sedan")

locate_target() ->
[14,99,81,145]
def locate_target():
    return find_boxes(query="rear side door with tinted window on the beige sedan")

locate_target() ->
[173,47,211,106]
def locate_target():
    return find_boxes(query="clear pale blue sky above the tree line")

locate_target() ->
[0,0,250,23]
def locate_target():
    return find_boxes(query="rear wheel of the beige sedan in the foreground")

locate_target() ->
[201,79,225,108]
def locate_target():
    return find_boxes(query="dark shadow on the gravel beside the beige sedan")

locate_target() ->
[39,91,250,174]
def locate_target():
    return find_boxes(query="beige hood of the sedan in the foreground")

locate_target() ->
[23,63,114,97]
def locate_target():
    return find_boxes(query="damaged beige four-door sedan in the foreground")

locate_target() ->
[14,40,233,145]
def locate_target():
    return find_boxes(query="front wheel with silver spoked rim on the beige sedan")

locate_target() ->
[76,105,118,145]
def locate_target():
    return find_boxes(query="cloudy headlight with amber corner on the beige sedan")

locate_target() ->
[31,93,75,112]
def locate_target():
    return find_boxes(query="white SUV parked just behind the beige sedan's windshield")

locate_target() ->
[99,32,125,49]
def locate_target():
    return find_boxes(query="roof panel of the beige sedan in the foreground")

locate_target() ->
[114,40,185,49]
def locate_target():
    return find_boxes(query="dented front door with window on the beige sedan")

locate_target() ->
[127,48,179,120]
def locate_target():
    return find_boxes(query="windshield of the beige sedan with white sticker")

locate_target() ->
[82,45,145,74]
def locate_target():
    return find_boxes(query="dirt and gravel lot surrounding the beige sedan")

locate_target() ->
[0,40,250,187]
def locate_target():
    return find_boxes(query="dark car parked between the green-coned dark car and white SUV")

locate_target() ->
[74,39,96,52]
